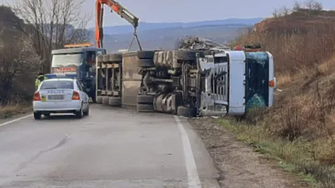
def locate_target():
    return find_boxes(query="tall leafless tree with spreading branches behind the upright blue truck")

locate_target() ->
[13,0,90,71]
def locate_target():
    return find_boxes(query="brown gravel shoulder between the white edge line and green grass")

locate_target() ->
[189,118,308,188]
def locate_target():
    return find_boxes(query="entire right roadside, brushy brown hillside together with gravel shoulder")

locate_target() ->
[191,5,335,188]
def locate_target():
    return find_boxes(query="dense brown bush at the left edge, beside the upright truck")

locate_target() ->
[0,35,41,105]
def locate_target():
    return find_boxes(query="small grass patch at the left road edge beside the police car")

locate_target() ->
[0,105,32,119]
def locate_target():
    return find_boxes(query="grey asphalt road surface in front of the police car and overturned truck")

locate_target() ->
[0,105,219,188]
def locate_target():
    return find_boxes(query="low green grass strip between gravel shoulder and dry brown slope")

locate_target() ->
[219,119,335,188]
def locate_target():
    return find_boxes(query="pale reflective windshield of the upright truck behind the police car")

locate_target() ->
[51,53,84,67]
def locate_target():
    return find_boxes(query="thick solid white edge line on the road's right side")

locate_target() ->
[174,116,201,188]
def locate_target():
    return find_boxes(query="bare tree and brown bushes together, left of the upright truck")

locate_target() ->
[0,0,92,106]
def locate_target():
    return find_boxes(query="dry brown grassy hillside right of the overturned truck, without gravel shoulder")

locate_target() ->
[223,5,335,188]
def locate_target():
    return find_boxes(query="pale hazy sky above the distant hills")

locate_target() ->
[0,0,335,27]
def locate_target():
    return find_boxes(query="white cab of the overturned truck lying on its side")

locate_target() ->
[199,50,276,116]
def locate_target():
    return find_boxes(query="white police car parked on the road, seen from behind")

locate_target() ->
[33,78,89,120]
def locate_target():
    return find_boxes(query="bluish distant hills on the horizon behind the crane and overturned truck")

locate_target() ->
[91,18,263,52]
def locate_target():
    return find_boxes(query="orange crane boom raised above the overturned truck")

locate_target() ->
[95,0,142,50]
